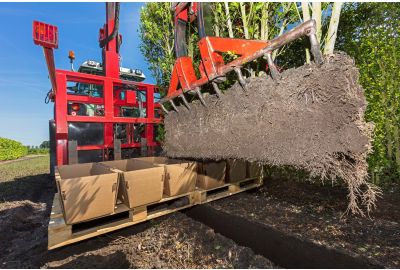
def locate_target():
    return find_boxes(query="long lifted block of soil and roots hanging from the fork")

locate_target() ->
[164,53,377,213]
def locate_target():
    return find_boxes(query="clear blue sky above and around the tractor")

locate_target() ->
[0,3,155,145]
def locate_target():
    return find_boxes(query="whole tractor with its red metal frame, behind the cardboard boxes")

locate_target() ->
[33,3,161,175]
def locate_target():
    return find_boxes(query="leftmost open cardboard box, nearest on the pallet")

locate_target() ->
[55,163,118,224]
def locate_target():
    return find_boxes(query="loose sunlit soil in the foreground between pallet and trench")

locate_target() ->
[44,213,273,268]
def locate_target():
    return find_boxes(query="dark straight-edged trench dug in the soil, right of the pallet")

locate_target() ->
[185,205,383,269]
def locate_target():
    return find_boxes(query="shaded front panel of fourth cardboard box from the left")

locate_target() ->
[196,161,226,189]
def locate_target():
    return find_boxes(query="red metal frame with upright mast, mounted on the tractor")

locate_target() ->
[33,3,161,165]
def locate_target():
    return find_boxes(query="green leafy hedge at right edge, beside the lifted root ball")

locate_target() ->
[338,3,400,186]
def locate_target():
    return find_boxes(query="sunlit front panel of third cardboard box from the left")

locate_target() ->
[164,162,197,196]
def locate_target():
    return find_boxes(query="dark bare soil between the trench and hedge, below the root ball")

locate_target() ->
[210,178,400,268]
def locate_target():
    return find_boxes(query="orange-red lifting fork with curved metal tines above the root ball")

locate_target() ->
[160,2,323,110]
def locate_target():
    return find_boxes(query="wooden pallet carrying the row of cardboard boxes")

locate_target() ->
[48,175,262,250]
